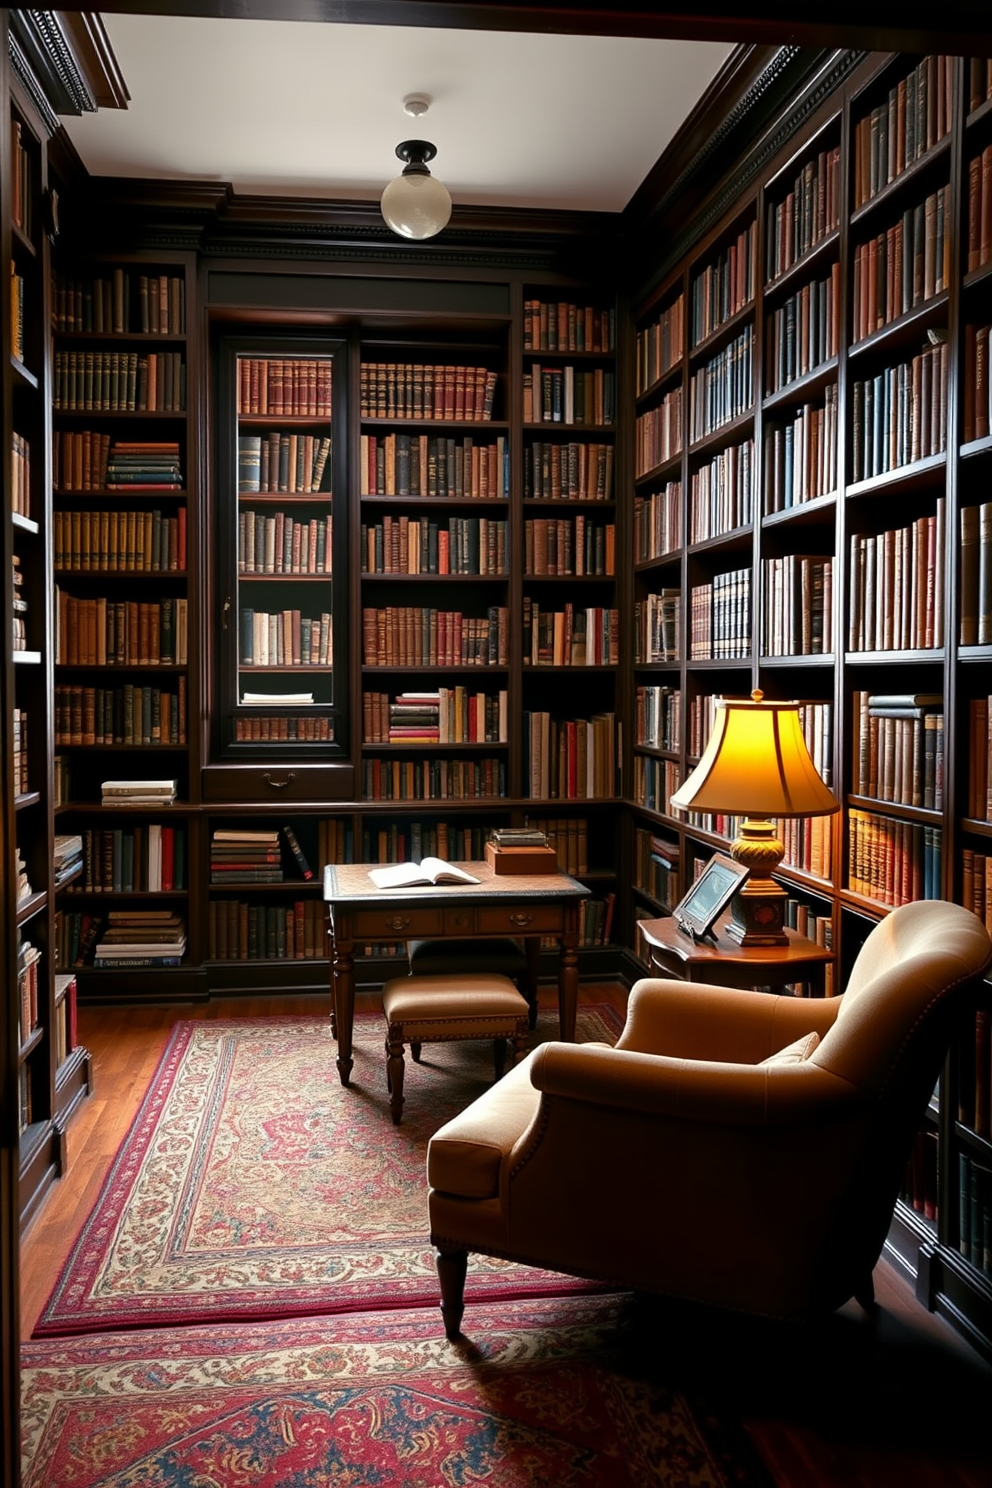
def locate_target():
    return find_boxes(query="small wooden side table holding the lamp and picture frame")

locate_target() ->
[638,914,834,997]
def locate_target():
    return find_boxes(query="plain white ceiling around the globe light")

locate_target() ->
[64,15,732,211]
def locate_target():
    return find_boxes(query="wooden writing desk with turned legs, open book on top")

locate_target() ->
[324,863,589,1085]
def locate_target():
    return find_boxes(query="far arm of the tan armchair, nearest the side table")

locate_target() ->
[616,978,840,1064]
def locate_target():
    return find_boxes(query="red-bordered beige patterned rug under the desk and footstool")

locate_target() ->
[34,1007,619,1338]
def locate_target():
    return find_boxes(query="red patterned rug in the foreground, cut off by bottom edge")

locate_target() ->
[21,1296,770,1488]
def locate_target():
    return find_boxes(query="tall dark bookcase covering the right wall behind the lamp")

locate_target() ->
[629,57,992,1350]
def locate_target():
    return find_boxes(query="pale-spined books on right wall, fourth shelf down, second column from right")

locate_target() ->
[848,496,946,652]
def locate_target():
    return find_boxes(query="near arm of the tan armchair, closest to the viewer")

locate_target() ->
[524,1035,866,1124]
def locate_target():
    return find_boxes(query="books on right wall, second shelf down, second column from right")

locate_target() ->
[852,186,950,341]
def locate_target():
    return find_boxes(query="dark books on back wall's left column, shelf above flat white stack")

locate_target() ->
[54,677,187,748]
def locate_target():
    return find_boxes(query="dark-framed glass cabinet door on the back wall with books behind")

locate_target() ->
[214,338,348,757]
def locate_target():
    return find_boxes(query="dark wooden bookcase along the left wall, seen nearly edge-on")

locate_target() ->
[3,72,89,1222]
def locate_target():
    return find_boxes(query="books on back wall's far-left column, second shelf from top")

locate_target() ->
[52,351,186,414]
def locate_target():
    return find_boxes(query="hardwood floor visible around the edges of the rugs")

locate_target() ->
[21,985,992,1488]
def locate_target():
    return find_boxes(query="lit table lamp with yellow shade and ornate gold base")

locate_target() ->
[671,689,840,946]
